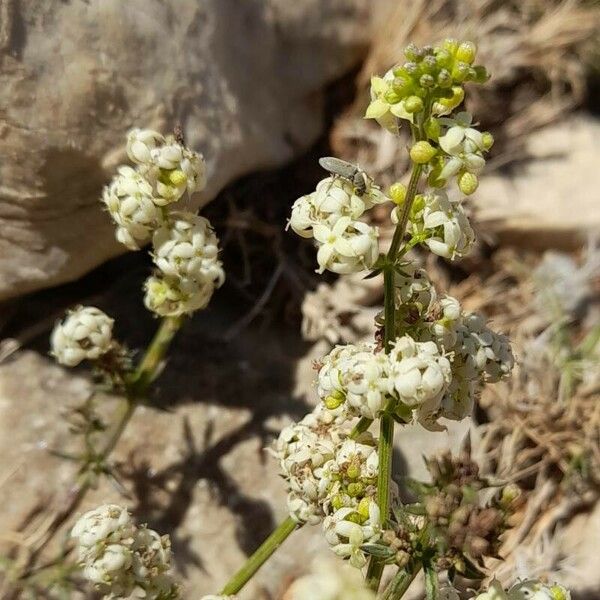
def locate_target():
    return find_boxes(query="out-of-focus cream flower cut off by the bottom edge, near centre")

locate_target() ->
[283,559,375,600]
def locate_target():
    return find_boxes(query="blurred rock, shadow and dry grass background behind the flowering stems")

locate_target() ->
[0,0,600,600]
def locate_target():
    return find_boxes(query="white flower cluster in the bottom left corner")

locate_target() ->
[71,504,180,600]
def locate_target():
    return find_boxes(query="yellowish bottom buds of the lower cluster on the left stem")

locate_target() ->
[144,276,215,317]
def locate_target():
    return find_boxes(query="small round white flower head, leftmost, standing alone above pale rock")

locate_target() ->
[50,306,114,367]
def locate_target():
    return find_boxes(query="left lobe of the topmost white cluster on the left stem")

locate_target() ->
[102,167,163,250]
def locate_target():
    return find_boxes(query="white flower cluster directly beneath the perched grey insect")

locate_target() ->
[289,176,388,274]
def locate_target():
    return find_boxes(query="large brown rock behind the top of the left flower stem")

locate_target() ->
[0,0,372,299]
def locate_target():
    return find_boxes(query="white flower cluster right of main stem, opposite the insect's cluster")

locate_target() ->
[392,190,475,260]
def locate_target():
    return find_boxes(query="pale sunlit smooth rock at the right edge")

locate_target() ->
[474,114,600,249]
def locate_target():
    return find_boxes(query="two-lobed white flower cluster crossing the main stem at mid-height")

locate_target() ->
[317,335,451,421]
